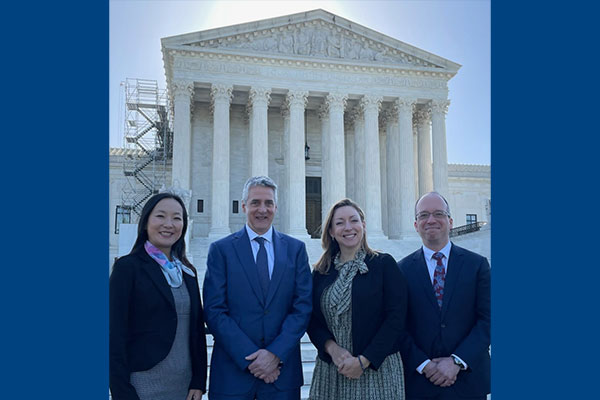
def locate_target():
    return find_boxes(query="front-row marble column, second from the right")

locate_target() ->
[396,98,416,238]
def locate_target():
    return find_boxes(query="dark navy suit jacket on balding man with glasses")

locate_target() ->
[398,243,490,398]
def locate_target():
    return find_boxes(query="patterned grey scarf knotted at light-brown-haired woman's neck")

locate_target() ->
[331,249,369,318]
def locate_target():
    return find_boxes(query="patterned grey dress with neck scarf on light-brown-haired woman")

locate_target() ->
[309,251,404,400]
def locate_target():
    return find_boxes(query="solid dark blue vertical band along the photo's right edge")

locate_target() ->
[492,1,600,400]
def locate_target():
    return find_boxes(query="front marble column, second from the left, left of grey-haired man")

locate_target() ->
[208,84,233,238]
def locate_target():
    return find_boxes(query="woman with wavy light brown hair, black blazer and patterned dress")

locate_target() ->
[308,199,407,400]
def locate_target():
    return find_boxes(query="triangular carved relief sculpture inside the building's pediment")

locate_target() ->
[192,26,437,67]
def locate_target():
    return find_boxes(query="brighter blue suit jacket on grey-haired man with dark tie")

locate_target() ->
[203,227,312,395]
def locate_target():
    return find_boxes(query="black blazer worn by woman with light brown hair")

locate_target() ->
[307,253,407,370]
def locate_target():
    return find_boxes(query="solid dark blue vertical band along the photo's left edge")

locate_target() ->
[0,1,109,399]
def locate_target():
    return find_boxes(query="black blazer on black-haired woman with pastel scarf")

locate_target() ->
[109,248,207,400]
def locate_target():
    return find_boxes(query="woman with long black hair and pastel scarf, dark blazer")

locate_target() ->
[109,193,207,400]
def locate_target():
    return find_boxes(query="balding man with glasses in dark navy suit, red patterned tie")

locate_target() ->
[398,192,490,400]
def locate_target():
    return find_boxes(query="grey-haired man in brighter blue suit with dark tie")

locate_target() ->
[203,176,312,400]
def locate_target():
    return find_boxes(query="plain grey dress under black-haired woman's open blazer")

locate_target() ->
[130,283,192,400]
